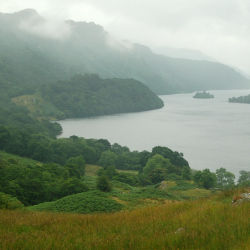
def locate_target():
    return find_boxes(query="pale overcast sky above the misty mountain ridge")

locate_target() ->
[0,0,250,74]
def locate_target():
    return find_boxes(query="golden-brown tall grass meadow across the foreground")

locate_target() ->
[0,190,250,250]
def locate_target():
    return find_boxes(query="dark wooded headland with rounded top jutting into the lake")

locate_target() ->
[41,75,163,118]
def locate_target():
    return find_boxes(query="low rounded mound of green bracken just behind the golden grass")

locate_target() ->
[30,191,123,214]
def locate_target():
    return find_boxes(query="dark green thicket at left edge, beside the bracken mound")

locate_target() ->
[0,152,87,205]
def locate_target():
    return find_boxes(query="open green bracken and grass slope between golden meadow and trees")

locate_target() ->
[28,176,212,214]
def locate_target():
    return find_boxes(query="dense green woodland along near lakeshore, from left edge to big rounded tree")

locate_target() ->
[0,122,191,205]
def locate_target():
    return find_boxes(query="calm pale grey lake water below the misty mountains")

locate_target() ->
[60,90,250,174]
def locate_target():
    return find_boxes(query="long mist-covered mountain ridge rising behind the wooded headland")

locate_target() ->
[0,10,250,95]
